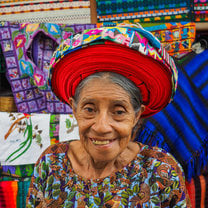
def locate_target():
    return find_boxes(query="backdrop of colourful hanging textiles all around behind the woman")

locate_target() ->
[0,0,208,208]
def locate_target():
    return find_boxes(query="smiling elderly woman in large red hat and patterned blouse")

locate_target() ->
[27,25,190,208]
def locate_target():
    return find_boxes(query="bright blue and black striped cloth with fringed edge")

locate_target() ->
[137,50,208,180]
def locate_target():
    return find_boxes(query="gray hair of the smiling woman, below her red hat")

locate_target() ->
[73,72,142,114]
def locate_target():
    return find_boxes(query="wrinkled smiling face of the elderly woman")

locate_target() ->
[72,78,141,162]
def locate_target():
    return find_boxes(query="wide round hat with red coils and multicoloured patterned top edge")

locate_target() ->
[49,24,177,118]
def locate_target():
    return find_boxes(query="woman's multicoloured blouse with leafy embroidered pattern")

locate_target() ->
[27,142,191,208]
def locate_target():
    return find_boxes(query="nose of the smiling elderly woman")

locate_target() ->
[92,112,112,134]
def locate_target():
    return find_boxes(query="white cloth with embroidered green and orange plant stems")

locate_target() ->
[0,112,79,165]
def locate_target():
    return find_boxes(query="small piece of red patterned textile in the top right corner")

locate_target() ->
[194,0,208,22]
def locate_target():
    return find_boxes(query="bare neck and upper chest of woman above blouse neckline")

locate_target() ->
[68,141,139,179]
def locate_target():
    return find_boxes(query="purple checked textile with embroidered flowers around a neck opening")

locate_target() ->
[0,22,95,113]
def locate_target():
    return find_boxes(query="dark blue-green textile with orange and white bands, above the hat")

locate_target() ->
[96,0,193,23]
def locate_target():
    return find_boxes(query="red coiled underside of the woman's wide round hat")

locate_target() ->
[51,44,172,118]
